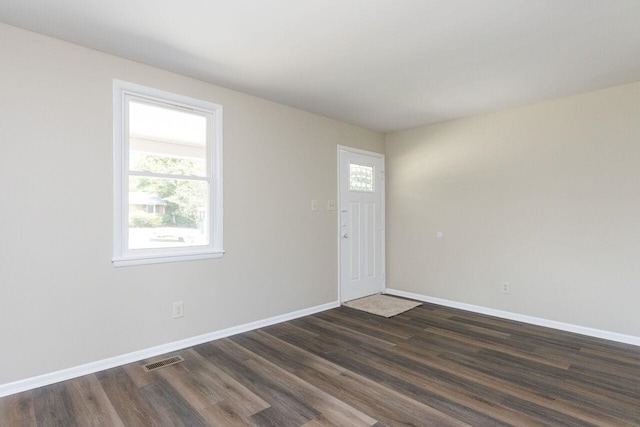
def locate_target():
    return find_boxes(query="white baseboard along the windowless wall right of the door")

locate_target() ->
[385,289,640,346]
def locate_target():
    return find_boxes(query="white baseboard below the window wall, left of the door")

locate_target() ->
[0,301,340,397]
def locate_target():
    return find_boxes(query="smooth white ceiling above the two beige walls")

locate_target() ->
[0,0,640,132]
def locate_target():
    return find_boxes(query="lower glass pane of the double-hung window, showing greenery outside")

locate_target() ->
[129,176,209,249]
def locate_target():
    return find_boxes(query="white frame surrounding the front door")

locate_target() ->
[336,144,387,304]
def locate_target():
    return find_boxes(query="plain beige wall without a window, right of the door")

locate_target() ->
[387,83,640,337]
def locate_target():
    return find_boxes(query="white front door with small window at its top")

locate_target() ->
[338,147,385,302]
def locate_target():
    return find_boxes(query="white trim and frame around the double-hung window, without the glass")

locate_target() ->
[112,79,224,267]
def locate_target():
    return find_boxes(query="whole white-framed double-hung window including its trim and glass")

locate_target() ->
[113,80,224,266]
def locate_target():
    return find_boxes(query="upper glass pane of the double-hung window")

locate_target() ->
[129,101,207,177]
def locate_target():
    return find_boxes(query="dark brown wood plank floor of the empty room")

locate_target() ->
[0,304,640,427]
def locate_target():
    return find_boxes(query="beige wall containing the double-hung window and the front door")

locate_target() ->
[0,24,384,384]
